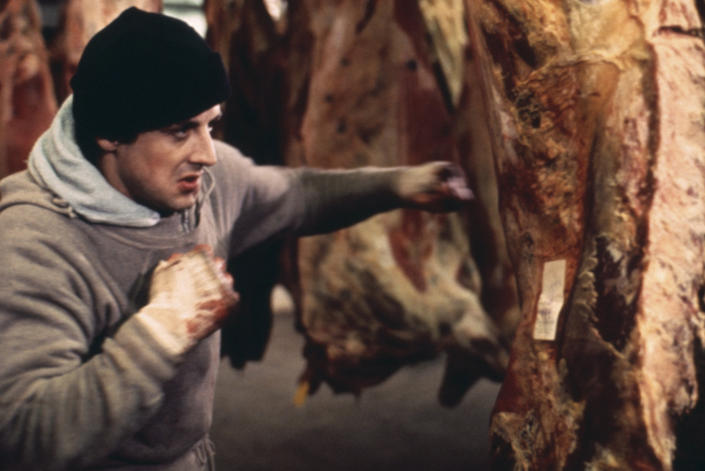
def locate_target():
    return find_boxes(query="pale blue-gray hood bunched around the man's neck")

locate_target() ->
[27,95,160,227]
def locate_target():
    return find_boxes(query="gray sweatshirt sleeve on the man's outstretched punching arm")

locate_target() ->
[218,143,404,253]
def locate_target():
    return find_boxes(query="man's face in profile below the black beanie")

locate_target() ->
[99,105,221,213]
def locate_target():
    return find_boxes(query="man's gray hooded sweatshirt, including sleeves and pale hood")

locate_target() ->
[0,99,399,471]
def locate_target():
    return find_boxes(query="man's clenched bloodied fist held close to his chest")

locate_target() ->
[139,245,239,352]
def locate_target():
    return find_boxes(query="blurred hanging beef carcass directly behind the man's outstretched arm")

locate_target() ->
[287,2,504,406]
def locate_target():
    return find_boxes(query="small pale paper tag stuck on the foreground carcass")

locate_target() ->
[534,260,566,341]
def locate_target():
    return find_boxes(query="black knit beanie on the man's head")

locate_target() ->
[71,7,230,140]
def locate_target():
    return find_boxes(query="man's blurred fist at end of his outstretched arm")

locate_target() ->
[397,162,473,212]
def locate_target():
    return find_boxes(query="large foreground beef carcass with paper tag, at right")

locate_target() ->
[466,0,705,470]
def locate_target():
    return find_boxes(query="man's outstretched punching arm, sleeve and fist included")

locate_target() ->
[217,141,473,256]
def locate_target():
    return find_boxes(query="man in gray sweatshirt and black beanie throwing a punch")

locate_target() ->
[0,8,471,470]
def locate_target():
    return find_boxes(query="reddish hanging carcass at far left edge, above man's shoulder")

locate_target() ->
[0,0,56,178]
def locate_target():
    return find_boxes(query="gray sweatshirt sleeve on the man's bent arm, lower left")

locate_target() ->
[0,211,184,470]
